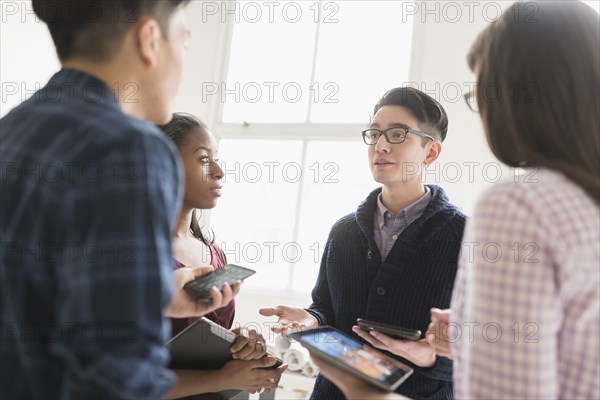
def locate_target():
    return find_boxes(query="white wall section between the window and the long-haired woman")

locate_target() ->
[411,1,511,214]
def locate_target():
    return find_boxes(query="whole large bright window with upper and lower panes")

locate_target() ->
[209,1,412,292]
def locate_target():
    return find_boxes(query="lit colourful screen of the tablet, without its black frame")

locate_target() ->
[299,330,410,383]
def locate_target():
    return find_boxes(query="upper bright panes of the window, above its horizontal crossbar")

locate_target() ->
[219,1,412,123]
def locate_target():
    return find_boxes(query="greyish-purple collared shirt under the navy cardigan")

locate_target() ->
[373,186,431,260]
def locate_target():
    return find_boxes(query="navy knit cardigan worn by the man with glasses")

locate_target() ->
[307,185,465,400]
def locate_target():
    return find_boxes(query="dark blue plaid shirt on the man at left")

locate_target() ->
[0,69,182,399]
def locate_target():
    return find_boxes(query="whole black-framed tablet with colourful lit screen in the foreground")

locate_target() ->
[288,326,413,392]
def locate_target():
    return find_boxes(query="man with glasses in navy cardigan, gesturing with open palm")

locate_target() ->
[260,87,465,399]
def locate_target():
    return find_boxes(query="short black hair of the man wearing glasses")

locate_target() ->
[373,87,448,142]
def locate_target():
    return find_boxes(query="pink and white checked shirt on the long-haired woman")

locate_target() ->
[448,170,600,399]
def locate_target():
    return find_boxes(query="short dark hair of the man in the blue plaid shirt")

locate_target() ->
[32,0,190,61]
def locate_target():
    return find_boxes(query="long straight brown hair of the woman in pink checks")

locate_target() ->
[468,1,600,203]
